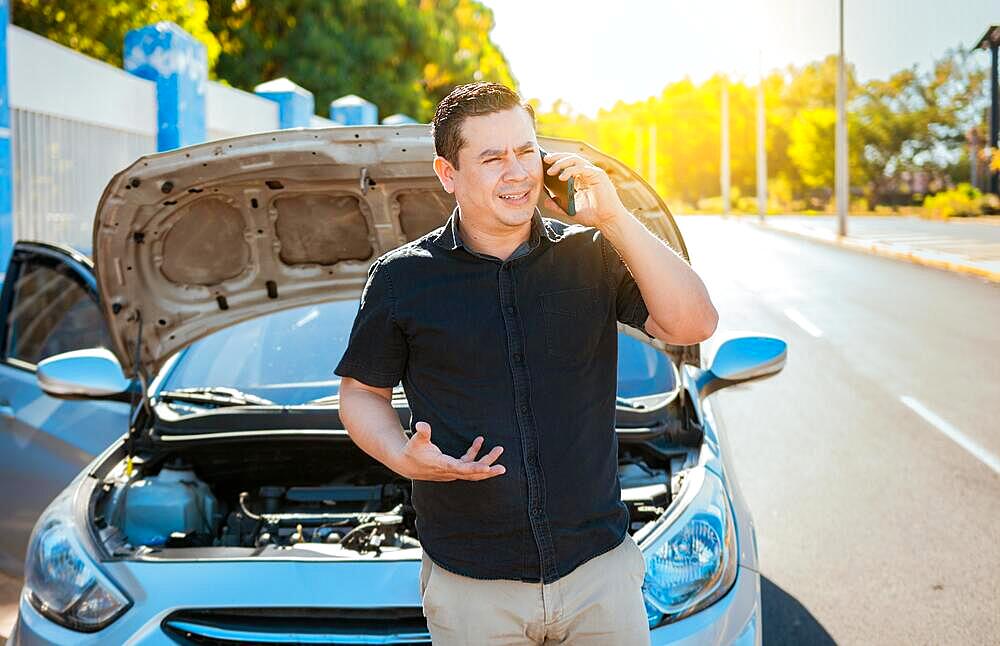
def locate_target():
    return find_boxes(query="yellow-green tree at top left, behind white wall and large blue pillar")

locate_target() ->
[11,0,219,70]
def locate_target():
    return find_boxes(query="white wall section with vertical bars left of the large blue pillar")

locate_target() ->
[7,25,156,253]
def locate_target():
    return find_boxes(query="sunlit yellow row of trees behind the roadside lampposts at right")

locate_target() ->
[538,47,985,213]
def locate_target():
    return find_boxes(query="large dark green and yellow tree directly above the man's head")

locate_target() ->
[208,0,516,121]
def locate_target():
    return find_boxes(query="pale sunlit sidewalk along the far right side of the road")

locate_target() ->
[729,215,1000,283]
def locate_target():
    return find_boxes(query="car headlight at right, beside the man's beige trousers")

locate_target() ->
[642,467,739,628]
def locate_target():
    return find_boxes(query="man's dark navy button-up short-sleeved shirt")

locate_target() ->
[334,207,648,583]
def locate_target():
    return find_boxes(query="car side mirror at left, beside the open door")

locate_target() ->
[35,348,138,401]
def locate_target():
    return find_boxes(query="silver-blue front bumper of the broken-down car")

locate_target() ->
[8,561,761,646]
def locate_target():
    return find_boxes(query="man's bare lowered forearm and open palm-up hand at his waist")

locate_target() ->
[340,377,505,481]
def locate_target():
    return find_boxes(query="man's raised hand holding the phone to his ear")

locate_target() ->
[542,151,628,228]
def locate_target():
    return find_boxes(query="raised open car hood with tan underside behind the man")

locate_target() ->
[93,124,697,377]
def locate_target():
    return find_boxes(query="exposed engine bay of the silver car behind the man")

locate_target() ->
[92,436,683,558]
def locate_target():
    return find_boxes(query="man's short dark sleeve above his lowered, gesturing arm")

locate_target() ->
[333,259,408,388]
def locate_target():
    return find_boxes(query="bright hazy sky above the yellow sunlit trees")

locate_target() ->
[485,0,1000,115]
